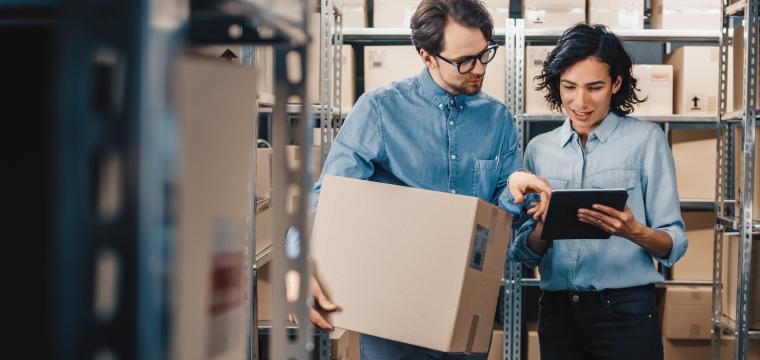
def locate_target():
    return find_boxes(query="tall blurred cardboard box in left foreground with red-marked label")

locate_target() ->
[170,57,256,359]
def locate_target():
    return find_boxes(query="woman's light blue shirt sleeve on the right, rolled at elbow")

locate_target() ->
[642,127,688,266]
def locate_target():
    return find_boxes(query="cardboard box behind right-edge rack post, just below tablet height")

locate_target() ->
[723,235,760,330]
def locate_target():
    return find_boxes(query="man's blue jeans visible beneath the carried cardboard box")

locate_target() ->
[360,334,488,360]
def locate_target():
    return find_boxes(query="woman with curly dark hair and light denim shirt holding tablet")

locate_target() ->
[510,24,687,360]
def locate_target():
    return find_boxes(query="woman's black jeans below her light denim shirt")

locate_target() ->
[538,285,663,360]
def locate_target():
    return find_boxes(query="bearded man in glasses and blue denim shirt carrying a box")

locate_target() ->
[311,0,551,359]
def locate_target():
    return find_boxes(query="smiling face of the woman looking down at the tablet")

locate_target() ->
[559,57,621,135]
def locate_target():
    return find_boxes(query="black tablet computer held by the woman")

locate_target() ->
[541,189,628,240]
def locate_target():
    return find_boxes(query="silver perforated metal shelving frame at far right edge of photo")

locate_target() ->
[711,0,760,360]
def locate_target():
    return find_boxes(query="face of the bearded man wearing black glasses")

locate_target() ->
[422,20,489,95]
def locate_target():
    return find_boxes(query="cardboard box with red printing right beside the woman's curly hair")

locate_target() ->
[633,64,673,116]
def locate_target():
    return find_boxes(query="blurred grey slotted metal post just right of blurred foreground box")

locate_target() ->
[270,0,315,360]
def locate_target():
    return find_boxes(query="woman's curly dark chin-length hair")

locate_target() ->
[535,24,646,115]
